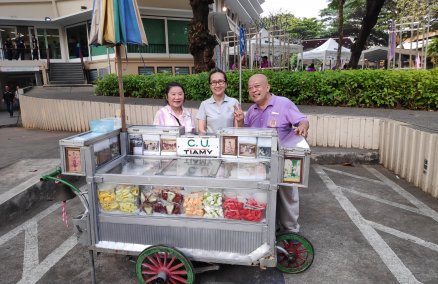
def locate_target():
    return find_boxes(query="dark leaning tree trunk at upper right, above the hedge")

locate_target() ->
[349,0,385,69]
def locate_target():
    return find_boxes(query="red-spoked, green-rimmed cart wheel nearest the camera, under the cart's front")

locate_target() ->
[135,246,195,284]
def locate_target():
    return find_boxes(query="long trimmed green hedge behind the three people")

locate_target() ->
[96,69,438,110]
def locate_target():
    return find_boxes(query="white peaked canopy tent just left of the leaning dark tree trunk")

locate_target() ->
[298,38,351,69]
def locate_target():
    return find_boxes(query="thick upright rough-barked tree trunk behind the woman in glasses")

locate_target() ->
[189,0,217,73]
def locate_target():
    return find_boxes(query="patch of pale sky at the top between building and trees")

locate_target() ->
[262,0,328,18]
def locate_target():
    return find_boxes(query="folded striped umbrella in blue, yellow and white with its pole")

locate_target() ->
[89,0,148,132]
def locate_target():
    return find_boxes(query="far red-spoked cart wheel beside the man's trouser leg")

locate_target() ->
[276,233,314,274]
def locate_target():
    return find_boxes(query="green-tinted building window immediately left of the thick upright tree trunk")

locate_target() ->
[167,20,189,54]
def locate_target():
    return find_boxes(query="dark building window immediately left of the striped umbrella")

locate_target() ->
[65,24,89,59]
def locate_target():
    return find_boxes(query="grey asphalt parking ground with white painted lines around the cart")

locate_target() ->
[0,161,438,284]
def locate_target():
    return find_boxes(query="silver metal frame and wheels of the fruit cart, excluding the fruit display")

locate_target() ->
[45,128,313,283]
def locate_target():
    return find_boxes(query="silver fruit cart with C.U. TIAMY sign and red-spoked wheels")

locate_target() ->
[49,126,313,283]
